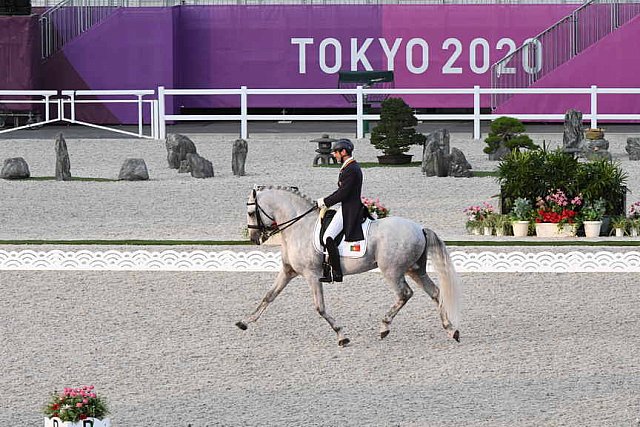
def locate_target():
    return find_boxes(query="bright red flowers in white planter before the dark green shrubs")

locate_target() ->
[535,189,582,237]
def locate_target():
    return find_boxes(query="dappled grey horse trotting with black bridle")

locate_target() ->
[236,186,461,346]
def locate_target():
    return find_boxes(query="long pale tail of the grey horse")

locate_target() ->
[422,228,462,327]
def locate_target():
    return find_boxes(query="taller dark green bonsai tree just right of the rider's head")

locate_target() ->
[371,98,427,156]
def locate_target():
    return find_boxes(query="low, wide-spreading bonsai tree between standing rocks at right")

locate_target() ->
[483,117,540,160]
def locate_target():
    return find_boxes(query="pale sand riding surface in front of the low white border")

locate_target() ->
[0,271,640,427]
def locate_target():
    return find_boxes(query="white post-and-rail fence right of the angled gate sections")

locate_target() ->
[158,86,640,139]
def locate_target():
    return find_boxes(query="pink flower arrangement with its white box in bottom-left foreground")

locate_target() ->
[44,385,111,427]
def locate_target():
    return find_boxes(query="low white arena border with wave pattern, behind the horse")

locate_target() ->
[0,250,640,273]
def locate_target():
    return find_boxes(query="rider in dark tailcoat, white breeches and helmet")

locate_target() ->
[317,138,364,282]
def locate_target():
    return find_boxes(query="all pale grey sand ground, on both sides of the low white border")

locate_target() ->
[0,130,640,427]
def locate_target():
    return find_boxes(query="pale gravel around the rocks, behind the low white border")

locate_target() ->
[0,130,640,240]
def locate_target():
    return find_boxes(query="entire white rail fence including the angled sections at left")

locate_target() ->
[0,86,640,139]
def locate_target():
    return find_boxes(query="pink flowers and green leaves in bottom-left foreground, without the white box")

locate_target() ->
[44,385,109,422]
